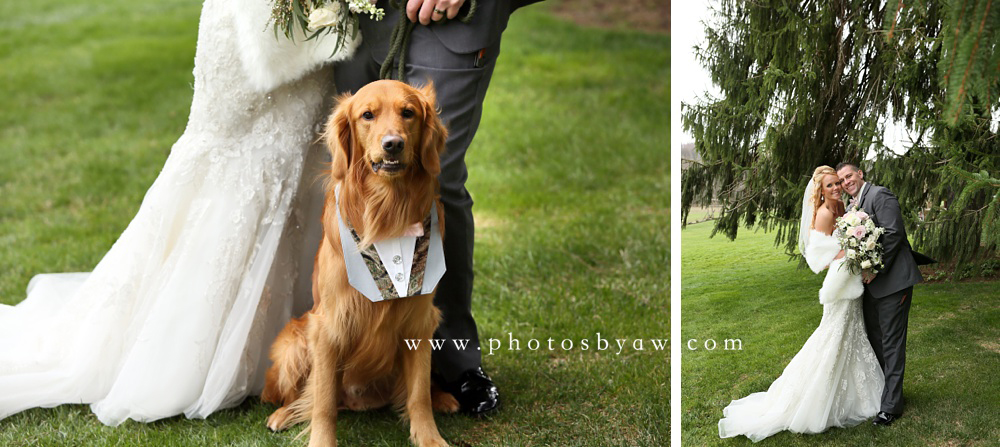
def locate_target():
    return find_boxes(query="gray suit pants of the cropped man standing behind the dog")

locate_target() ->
[302,8,506,381]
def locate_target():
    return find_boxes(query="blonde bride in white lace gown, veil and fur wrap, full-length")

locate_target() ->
[719,166,884,442]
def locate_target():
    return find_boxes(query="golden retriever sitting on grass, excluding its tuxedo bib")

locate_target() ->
[262,81,458,446]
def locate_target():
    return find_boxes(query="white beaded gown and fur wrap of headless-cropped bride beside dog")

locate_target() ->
[0,0,358,425]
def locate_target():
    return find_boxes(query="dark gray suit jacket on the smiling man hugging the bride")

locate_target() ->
[858,183,923,298]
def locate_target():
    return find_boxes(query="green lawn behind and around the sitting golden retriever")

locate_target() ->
[0,0,670,446]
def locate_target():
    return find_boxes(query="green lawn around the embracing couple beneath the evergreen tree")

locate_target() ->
[681,222,1000,447]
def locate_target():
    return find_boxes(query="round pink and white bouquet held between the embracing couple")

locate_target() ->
[834,207,885,275]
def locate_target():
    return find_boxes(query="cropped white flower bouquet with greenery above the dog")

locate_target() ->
[271,0,385,52]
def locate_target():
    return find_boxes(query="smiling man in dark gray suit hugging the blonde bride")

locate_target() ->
[837,163,923,425]
